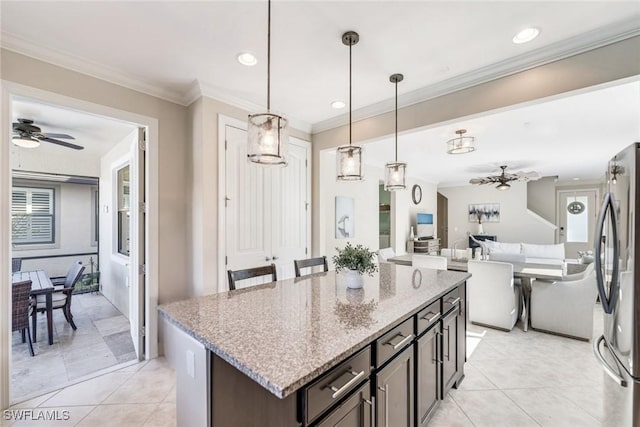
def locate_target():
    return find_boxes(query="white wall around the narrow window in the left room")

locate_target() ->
[100,129,138,318]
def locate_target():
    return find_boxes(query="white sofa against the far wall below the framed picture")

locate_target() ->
[482,240,565,265]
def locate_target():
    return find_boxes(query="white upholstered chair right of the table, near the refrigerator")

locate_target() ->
[531,264,598,341]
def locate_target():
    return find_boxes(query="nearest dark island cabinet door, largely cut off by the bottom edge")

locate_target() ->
[317,381,373,427]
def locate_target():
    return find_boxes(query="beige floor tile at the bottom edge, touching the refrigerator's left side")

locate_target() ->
[504,388,601,427]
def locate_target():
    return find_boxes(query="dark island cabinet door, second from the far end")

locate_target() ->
[416,323,441,426]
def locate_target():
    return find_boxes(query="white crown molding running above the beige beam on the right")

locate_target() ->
[311,19,640,134]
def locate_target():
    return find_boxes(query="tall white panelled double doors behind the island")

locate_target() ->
[225,125,309,286]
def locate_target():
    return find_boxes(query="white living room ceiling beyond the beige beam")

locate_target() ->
[364,79,640,187]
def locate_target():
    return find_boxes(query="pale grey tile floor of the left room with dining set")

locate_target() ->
[11,293,136,402]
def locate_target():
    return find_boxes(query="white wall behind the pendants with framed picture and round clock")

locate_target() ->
[318,150,437,268]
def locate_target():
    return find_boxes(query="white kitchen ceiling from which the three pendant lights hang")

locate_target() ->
[0,0,640,130]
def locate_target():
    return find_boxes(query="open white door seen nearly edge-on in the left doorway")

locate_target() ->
[129,128,146,360]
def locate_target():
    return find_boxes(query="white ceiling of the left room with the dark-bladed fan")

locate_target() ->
[11,98,136,162]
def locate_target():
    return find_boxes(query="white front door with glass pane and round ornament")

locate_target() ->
[558,190,598,258]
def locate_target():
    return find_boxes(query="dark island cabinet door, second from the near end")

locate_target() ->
[376,346,414,427]
